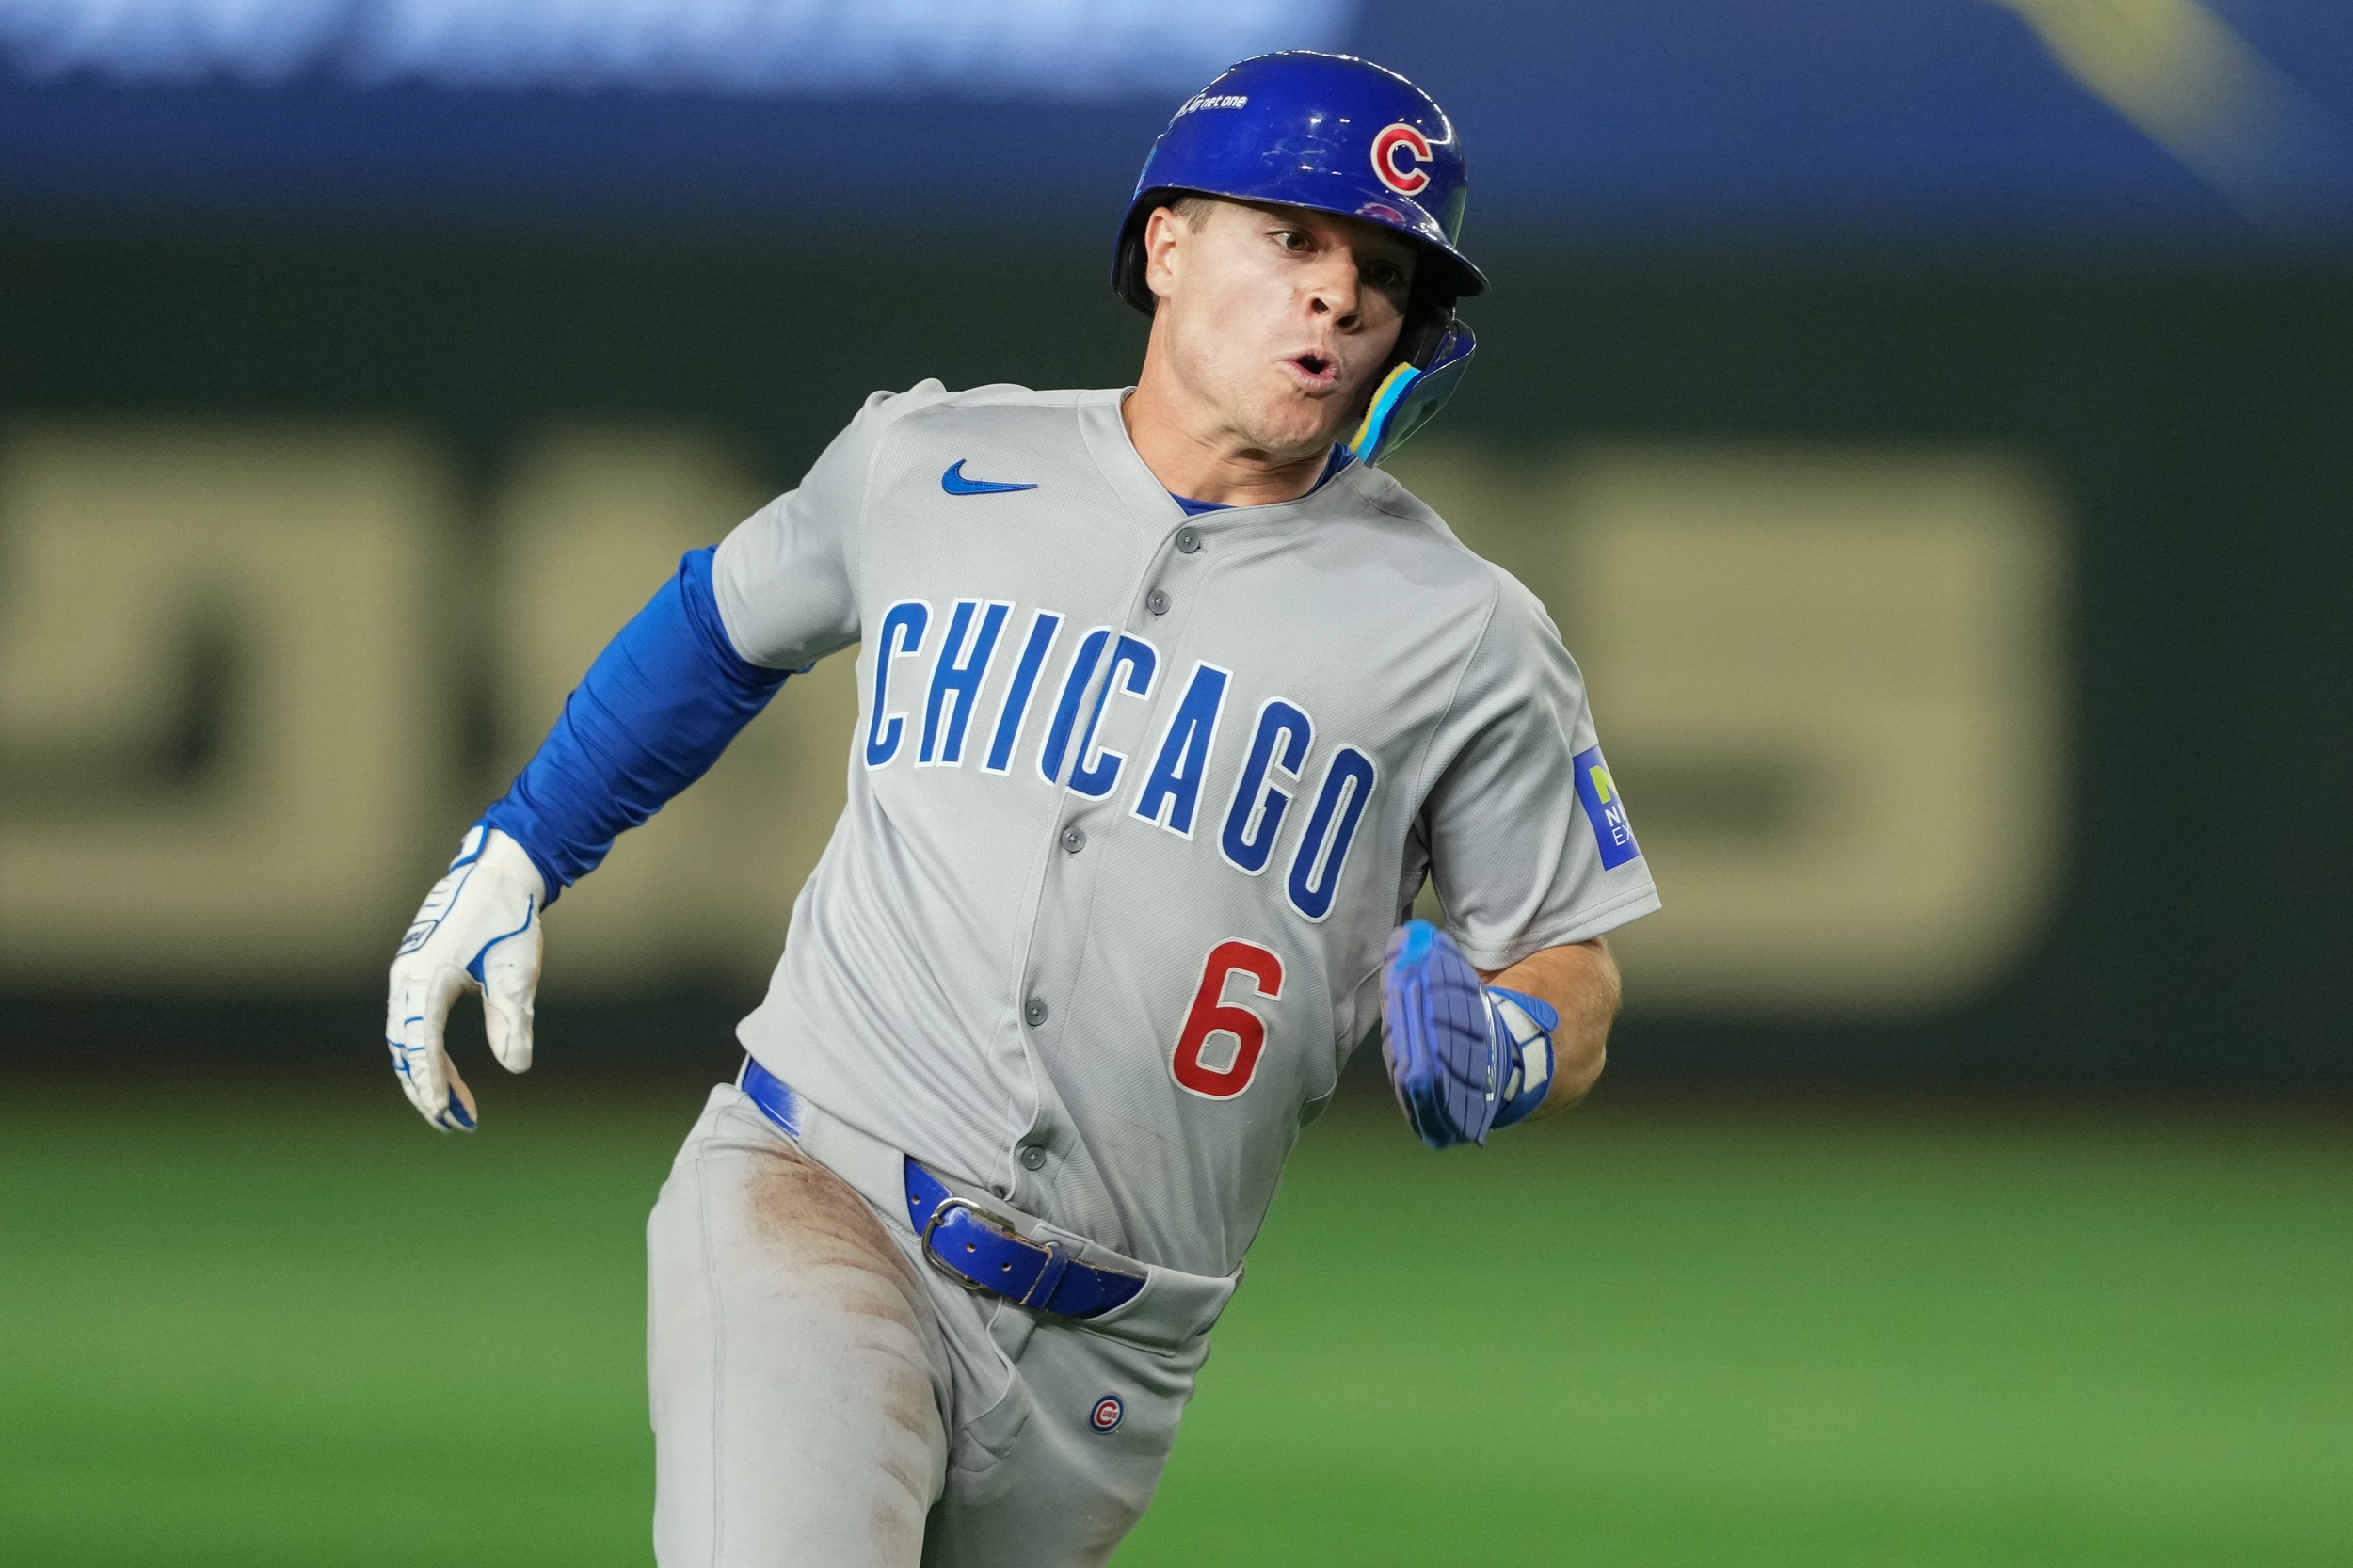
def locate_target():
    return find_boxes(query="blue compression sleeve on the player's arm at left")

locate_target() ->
[483,549,786,904]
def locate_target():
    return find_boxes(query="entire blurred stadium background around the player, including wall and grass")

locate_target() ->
[0,0,2353,1563]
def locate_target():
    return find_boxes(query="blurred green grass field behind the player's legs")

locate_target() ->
[0,1083,2353,1568]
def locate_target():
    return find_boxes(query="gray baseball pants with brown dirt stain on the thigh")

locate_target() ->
[648,1085,1238,1568]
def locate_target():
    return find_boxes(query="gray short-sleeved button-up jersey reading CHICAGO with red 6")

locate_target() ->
[715,381,1659,1273]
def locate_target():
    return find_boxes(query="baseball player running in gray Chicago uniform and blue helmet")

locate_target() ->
[386,52,1659,1568]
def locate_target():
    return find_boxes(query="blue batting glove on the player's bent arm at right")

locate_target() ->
[1382,920,1561,1149]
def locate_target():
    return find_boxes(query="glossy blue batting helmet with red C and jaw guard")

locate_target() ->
[1111,50,1487,464]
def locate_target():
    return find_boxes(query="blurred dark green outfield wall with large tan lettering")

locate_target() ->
[0,229,2353,1088]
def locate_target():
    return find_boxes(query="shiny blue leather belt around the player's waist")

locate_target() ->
[737,1057,1144,1319]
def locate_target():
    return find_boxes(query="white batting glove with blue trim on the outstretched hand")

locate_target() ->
[384,824,546,1132]
